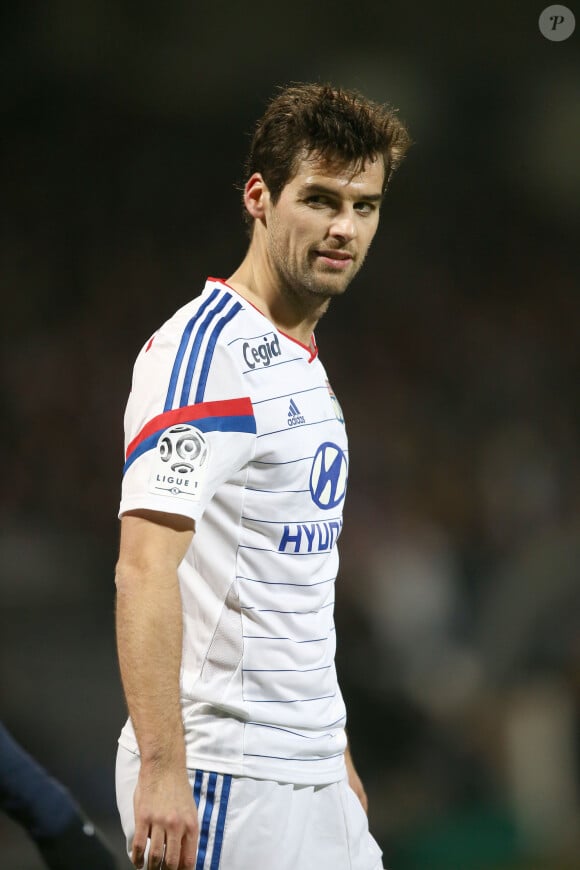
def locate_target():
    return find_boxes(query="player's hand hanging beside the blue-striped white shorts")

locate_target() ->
[131,766,199,870]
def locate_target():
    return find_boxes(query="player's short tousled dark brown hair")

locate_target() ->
[244,83,411,221]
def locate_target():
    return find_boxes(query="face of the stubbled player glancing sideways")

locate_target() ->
[266,157,384,300]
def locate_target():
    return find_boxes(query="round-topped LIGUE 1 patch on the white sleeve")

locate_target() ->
[149,425,209,501]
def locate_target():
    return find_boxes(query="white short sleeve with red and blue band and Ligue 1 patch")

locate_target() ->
[119,311,256,520]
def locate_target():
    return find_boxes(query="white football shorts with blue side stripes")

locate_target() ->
[116,746,383,870]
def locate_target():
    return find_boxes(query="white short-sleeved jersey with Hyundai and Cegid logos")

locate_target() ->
[115,279,348,784]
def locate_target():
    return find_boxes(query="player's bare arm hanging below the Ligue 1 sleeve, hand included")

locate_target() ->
[115,511,198,870]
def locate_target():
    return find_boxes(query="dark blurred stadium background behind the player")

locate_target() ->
[0,0,580,870]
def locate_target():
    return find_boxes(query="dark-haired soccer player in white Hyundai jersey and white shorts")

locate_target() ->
[116,84,409,870]
